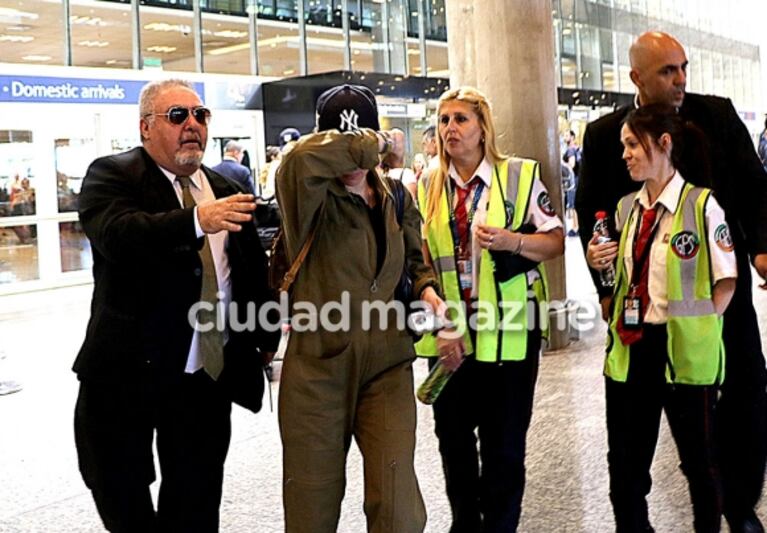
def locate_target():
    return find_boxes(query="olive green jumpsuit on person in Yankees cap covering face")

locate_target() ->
[277,130,437,533]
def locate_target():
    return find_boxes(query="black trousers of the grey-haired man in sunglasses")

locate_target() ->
[75,370,231,533]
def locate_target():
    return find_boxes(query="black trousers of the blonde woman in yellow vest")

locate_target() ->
[434,330,541,533]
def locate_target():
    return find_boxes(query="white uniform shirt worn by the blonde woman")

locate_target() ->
[448,159,563,298]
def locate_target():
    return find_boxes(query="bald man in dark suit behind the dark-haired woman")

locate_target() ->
[576,32,767,533]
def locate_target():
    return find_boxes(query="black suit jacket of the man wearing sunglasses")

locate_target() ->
[74,148,277,404]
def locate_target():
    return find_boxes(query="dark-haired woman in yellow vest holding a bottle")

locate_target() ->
[587,105,737,532]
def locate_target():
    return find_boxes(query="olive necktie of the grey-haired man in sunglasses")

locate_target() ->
[176,176,224,379]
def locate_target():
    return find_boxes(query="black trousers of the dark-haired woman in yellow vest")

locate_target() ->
[605,325,722,533]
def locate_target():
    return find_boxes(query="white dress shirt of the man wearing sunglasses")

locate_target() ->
[160,167,232,374]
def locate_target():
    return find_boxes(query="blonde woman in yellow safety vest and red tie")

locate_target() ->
[417,87,564,532]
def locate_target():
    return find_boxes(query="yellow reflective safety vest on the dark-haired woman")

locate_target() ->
[605,183,724,385]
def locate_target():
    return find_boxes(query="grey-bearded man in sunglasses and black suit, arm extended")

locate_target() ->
[74,80,276,533]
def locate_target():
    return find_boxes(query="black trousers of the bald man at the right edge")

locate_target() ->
[717,254,767,533]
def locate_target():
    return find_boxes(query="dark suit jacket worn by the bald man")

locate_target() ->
[576,93,767,296]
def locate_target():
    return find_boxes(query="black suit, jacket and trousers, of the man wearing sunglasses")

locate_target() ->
[74,148,275,532]
